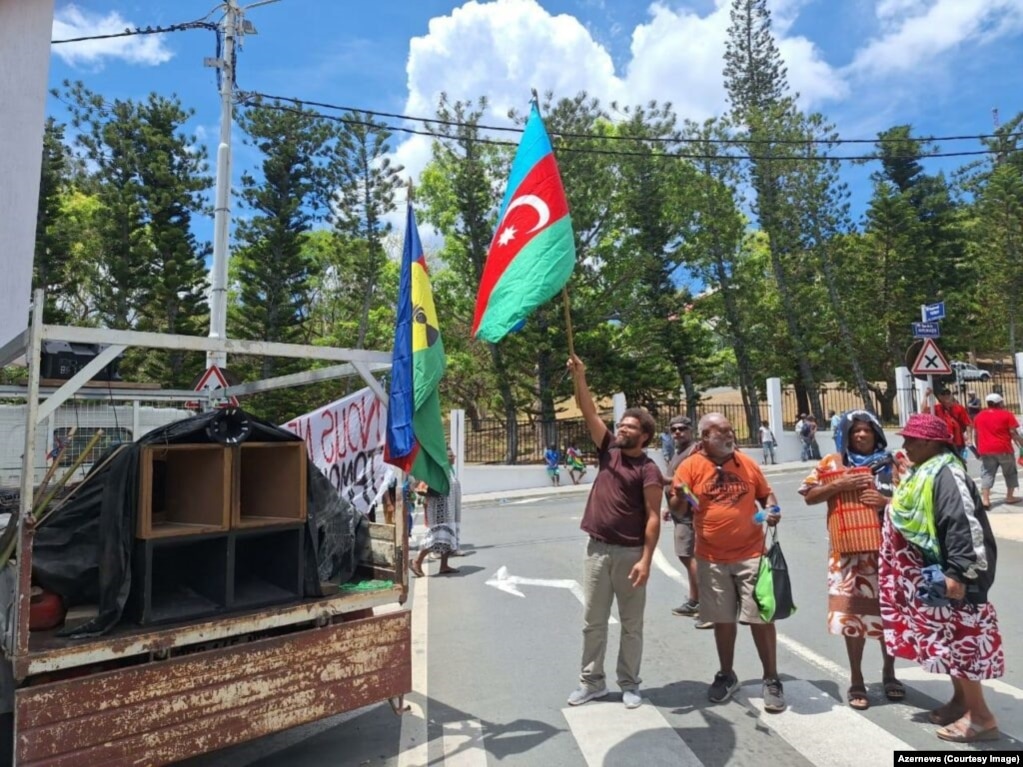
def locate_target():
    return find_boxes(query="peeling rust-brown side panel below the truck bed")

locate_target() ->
[15,611,411,767]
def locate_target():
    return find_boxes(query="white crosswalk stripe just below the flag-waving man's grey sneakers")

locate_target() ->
[562,700,703,767]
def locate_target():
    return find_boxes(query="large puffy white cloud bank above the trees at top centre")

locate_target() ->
[407,0,846,134]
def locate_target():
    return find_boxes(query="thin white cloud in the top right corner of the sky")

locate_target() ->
[849,0,1023,79]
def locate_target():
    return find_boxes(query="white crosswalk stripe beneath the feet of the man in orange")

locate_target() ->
[739,680,913,767]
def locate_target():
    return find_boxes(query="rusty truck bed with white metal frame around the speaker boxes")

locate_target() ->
[0,302,411,767]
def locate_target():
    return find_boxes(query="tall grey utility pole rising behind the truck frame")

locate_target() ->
[206,0,241,367]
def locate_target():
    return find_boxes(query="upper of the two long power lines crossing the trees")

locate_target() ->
[247,91,1023,150]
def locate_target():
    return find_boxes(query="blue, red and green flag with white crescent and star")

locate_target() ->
[473,101,575,344]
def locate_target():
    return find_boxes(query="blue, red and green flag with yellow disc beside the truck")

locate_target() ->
[384,201,451,495]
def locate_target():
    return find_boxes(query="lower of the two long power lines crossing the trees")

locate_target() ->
[241,91,996,163]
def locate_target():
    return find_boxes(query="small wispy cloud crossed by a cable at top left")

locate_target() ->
[52,5,173,67]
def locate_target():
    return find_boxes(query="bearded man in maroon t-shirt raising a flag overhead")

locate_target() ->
[568,355,664,709]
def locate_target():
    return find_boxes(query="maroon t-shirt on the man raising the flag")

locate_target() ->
[579,432,662,546]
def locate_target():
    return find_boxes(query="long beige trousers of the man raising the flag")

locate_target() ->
[579,538,647,690]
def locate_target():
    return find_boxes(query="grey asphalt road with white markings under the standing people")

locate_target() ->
[188,470,1023,767]
